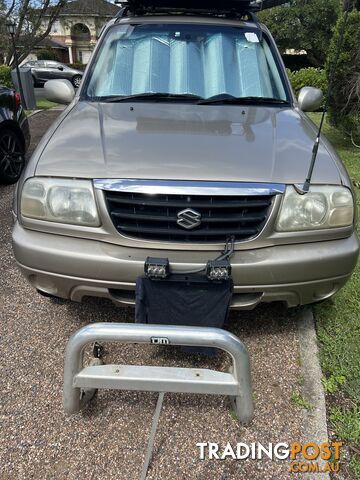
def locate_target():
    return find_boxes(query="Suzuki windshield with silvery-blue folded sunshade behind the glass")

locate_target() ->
[85,23,287,101]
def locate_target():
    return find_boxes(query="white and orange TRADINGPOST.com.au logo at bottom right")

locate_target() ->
[196,442,344,473]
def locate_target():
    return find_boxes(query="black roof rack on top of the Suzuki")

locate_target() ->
[116,0,288,19]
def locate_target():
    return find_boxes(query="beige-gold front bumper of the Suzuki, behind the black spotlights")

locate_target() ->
[13,222,359,309]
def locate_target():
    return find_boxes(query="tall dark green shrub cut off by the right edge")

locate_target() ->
[326,10,360,139]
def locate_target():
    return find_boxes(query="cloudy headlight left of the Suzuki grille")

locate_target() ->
[21,177,100,227]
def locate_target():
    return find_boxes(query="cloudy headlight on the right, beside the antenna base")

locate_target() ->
[276,185,354,232]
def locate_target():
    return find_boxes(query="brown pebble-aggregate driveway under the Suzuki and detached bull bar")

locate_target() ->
[0,111,326,480]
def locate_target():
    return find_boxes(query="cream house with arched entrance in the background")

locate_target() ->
[40,0,120,64]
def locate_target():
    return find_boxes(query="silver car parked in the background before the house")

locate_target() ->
[21,60,83,88]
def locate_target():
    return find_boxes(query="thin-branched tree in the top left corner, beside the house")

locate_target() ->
[0,0,68,65]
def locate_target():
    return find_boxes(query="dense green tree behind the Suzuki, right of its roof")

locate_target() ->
[259,0,340,67]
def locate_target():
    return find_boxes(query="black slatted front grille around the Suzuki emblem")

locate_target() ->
[105,191,273,243]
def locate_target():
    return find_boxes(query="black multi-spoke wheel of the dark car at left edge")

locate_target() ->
[0,129,25,185]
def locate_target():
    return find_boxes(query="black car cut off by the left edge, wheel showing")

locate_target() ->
[0,85,30,184]
